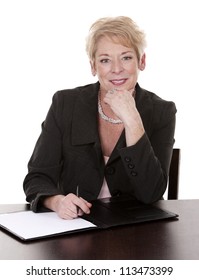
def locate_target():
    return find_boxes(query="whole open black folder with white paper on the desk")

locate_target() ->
[0,196,178,241]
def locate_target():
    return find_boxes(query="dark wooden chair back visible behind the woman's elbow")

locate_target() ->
[167,148,180,199]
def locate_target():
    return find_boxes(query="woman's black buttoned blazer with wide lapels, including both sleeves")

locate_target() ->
[24,82,176,211]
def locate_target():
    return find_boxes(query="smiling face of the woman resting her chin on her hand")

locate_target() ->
[91,37,145,92]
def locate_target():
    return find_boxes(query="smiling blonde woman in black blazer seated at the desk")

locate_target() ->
[24,17,176,219]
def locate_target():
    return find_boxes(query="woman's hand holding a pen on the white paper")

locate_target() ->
[43,193,92,220]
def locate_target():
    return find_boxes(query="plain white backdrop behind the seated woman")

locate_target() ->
[0,0,199,203]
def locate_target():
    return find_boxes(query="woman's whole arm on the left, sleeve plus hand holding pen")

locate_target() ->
[24,89,91,219]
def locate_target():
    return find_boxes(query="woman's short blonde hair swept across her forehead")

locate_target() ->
[86,16,146,61]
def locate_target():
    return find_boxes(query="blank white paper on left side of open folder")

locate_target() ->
[0,211,96,240]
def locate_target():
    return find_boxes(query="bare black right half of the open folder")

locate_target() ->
[83,196,178,229]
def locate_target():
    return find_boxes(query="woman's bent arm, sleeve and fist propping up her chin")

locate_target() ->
[104,87,176,203]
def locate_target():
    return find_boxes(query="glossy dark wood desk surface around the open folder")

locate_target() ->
[0,199,199,260]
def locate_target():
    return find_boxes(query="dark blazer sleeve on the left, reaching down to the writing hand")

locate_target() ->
[23,93,63,211]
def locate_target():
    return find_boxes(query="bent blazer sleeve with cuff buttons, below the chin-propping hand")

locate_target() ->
[120,101,176,203]
